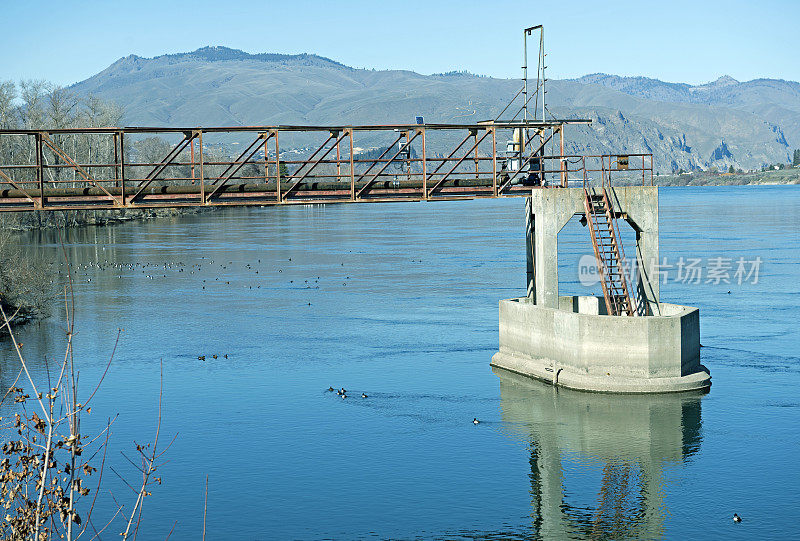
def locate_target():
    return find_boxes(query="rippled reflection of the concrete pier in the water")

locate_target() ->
[493,368,704,539]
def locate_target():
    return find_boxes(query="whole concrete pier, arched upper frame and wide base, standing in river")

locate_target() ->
[492,186,711,393]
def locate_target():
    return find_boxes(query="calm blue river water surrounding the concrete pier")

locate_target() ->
[0,186,800,539]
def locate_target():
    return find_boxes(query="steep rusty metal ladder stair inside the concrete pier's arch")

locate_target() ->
[583,184,639,316]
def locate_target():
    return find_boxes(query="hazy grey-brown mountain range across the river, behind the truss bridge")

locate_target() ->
[71,47,800,172]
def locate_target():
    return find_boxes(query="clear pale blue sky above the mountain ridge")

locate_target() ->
[0,0,800,85]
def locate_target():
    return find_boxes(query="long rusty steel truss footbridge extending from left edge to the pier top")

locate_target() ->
[0,120,653,211]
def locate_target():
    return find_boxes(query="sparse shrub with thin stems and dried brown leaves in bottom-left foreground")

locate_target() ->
[0,254,174,541]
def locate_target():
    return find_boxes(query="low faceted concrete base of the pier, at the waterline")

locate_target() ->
[491,297,711,393]
